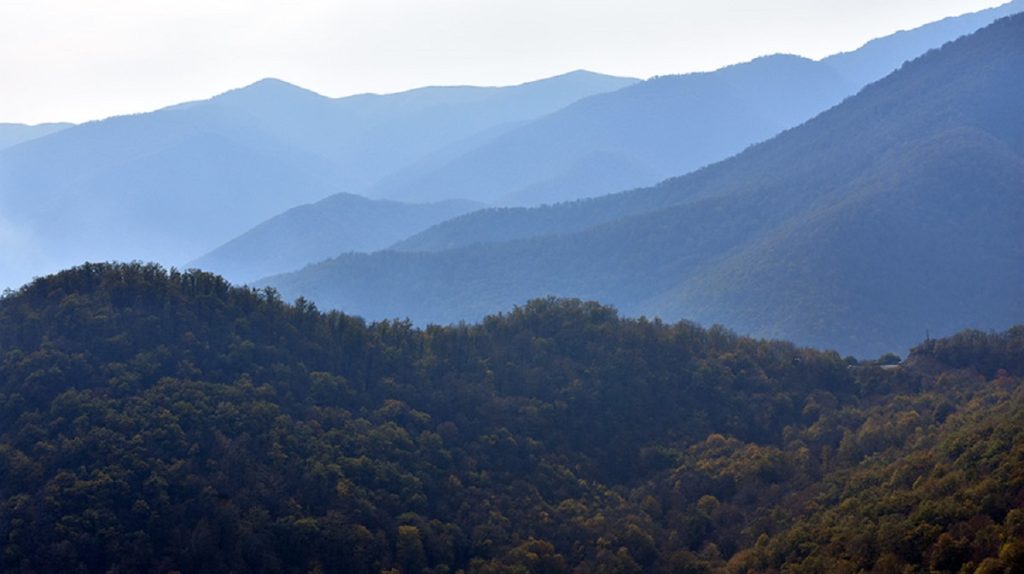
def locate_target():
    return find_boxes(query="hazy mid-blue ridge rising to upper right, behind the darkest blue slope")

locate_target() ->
[375,0,1024,206]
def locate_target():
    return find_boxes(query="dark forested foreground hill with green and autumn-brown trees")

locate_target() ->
[0,264,1024,573]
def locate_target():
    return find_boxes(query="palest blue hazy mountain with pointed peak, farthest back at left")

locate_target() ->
[0,72,634,286]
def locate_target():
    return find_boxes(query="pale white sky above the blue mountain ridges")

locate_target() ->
[0,0,1005,123]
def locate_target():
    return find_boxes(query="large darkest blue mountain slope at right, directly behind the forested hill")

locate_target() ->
[267,15,1024,356]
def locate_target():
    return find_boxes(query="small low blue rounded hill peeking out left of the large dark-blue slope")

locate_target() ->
[188,193,482,282]
